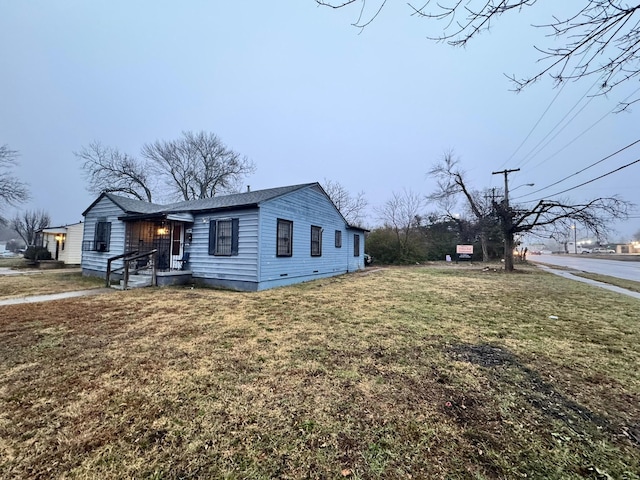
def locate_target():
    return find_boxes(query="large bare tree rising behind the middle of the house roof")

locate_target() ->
[142,131,255,200]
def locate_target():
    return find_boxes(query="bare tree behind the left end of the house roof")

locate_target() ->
[74,141,152,202]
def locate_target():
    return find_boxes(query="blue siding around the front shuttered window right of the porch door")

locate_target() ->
[189,209,258,282]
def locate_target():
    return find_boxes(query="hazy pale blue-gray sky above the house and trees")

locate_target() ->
[0,0,640,241]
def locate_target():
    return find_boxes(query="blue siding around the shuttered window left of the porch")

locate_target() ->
[82,197,125,273]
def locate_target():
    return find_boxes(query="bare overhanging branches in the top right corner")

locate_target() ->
[316,0,640,108]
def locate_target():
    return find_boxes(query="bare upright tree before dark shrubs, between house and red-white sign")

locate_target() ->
[376,189,426,258]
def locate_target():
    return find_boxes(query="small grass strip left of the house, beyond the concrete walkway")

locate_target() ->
[0,269,104,299]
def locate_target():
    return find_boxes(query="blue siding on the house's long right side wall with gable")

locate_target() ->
[259,188,364,289]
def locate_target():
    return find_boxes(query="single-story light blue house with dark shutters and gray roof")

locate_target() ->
[82,183,365,291]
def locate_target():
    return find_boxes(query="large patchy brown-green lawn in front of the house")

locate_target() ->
[0,266,640,479]
